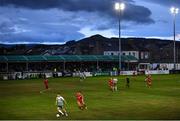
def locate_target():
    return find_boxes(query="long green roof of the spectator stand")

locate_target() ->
[0,55,138,62]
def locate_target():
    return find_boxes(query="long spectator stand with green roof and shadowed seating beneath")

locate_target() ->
[0,55,138,79]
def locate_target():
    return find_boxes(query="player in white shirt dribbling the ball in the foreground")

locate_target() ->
[56,94,68,117]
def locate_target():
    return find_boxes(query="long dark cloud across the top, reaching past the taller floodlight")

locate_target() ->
[0,0,154,24]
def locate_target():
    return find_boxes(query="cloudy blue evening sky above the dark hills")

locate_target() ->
[0,0,180,44]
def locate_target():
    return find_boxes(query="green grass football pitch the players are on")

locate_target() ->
[0,75,180,120]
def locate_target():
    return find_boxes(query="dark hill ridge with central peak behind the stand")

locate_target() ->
[0,35,180,62]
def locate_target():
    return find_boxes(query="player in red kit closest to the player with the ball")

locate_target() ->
[76,91,87,110]
